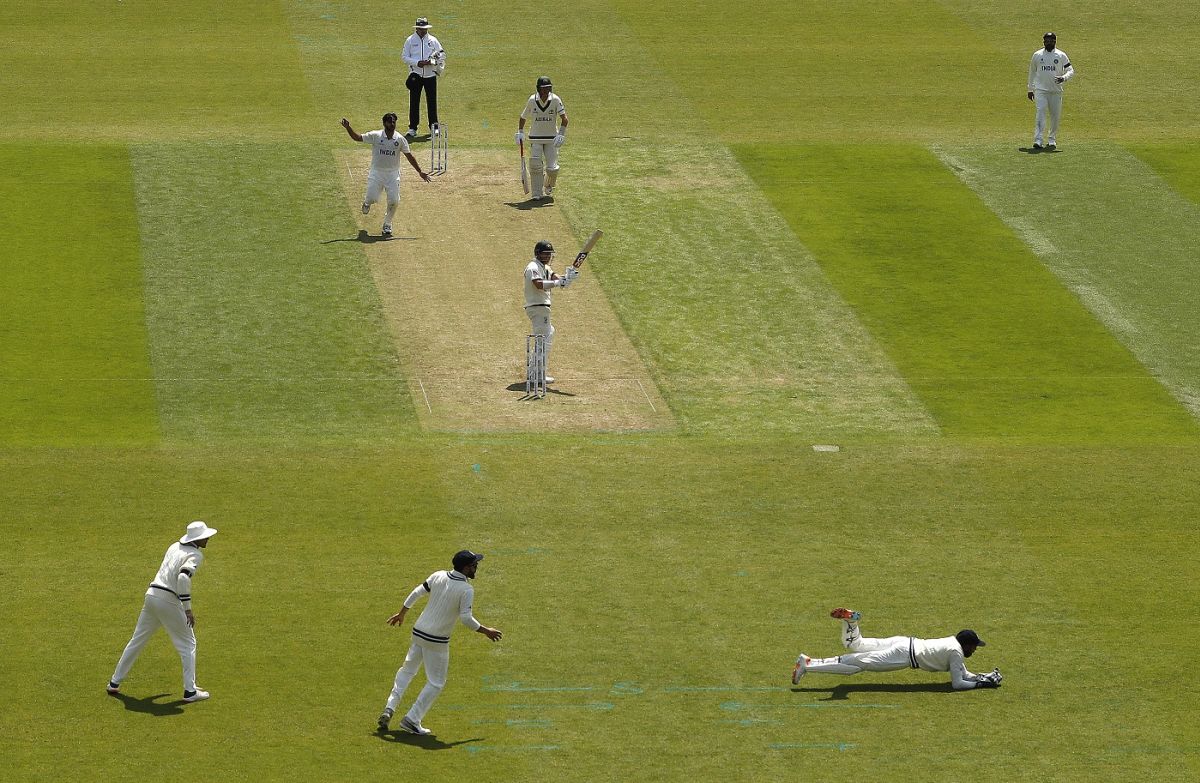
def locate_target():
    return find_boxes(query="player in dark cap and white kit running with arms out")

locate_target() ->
[378,549,504,734]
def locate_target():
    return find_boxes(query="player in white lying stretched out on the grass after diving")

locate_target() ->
[792,608,1003,691]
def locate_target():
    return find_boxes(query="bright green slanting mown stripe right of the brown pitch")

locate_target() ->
[736,144,1196,440]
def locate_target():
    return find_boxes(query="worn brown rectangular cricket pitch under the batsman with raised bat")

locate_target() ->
[336,143,674,431]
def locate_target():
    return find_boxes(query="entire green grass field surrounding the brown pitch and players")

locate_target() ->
[0,0,1200,783]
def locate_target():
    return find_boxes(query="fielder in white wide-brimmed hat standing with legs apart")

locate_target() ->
[107,521,217,703]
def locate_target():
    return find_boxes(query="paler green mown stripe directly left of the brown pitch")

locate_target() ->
[133,143,414,441]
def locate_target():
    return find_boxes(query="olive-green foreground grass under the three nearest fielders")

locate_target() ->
[0,437,1200,782]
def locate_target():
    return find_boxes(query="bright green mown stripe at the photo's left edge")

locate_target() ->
[0,142,158,443]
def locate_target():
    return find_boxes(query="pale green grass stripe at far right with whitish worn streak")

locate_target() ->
[940,143,1200,417]
